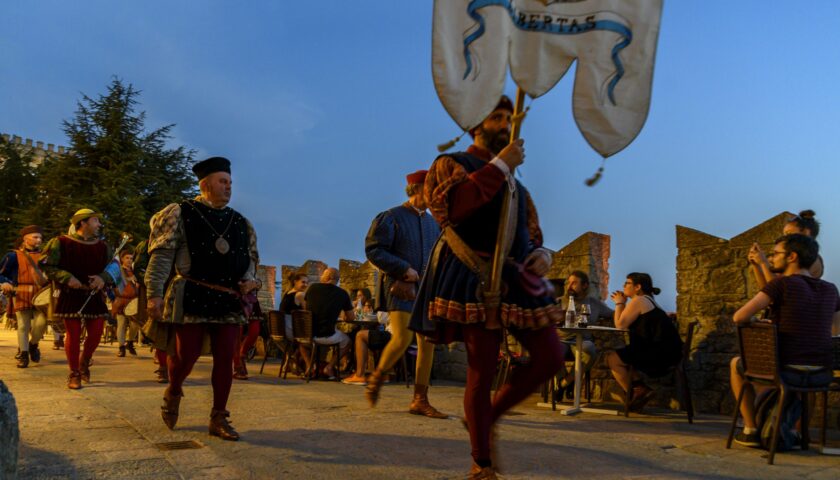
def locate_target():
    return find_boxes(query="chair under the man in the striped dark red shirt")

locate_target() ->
[726,323,830,465]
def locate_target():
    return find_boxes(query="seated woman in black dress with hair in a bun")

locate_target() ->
[607,272,682,411]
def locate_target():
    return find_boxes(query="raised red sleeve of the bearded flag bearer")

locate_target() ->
[424,156,505,227]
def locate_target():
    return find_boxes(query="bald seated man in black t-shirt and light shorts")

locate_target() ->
[304,268,355,378]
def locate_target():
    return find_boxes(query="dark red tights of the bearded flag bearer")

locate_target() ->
[462,325,566,465]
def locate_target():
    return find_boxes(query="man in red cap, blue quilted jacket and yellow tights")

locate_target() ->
[364,170,447,418]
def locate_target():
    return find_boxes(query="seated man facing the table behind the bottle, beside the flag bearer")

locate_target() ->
[554,270,614,400]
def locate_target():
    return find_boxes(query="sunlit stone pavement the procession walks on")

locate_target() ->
[0,329,840,480]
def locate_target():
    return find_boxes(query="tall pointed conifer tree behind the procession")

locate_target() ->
[22,78,195,248]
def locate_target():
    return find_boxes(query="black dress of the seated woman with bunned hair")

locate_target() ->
[615,296,682,377]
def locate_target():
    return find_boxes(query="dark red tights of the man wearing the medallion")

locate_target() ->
[168,323,240,410]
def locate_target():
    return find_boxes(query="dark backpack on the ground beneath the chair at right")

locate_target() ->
[755,388,802,452]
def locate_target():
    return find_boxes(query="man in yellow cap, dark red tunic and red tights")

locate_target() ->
[42,208,115,390]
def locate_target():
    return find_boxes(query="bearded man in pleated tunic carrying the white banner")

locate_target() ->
[411,97,565,479]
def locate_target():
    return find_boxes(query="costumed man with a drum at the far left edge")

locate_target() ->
[0,225,47,368]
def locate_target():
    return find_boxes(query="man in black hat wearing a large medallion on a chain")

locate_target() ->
[146,157,260,440]
